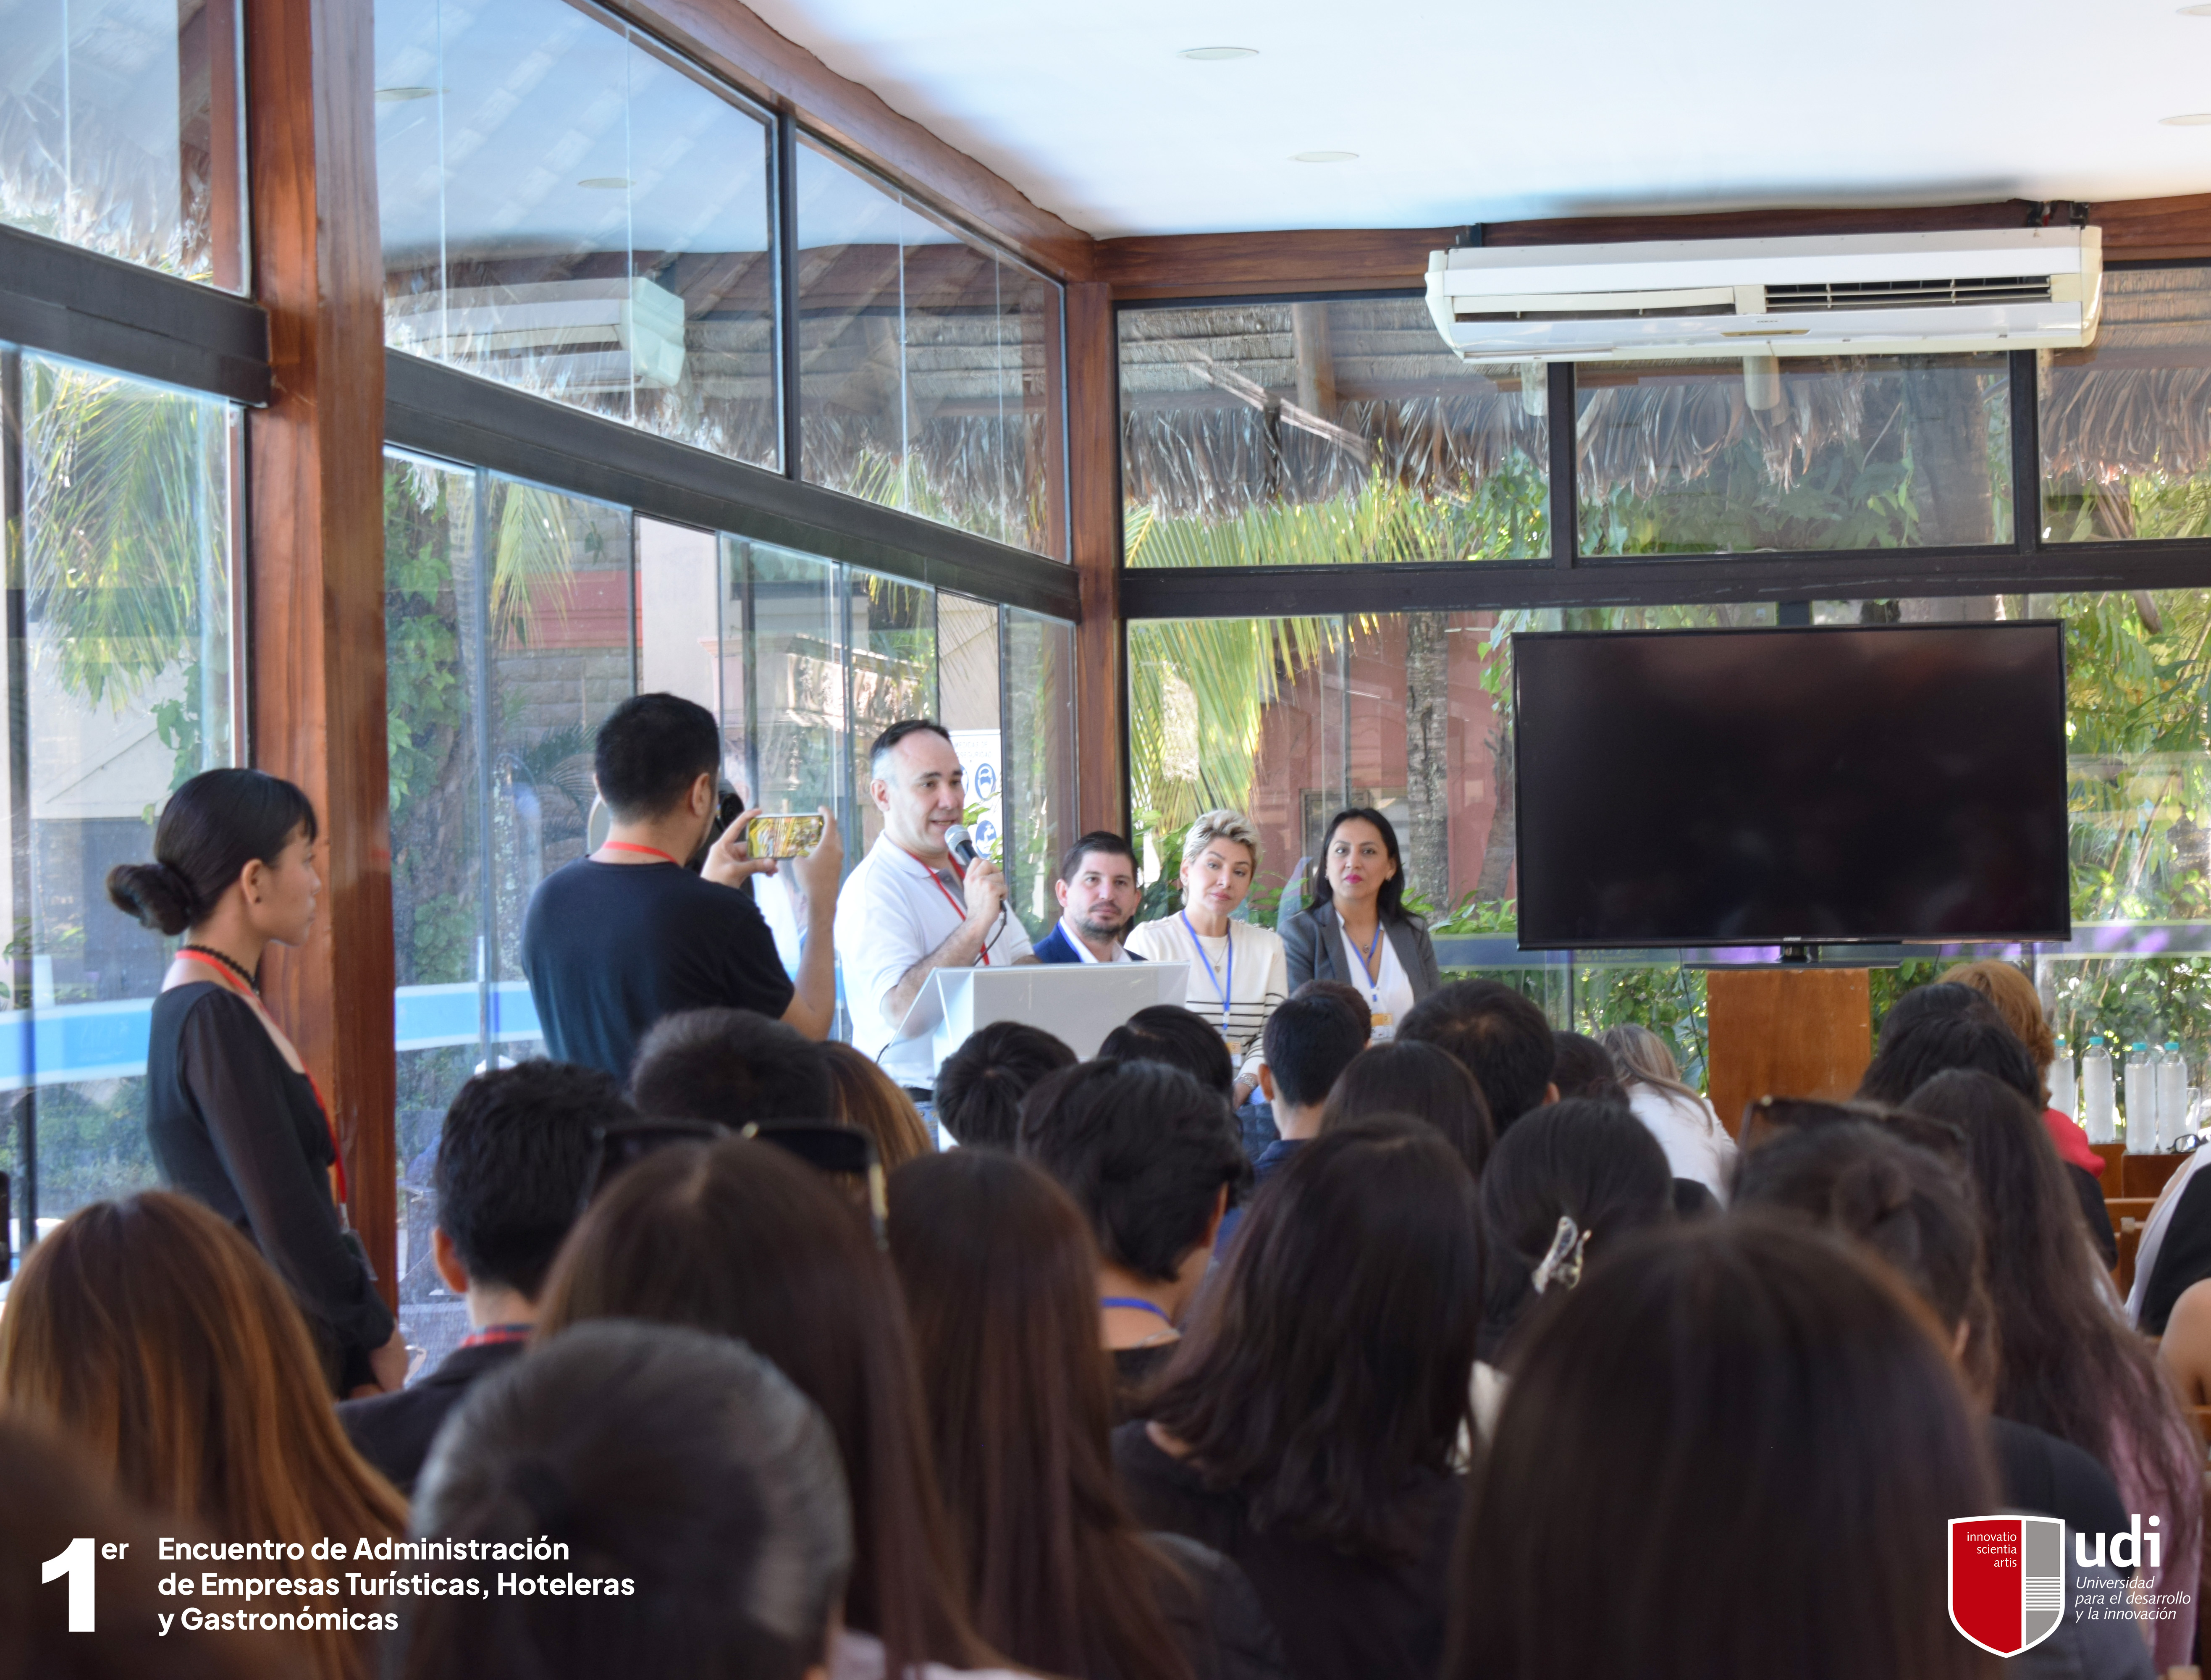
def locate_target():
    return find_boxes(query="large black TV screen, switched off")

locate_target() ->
[1512,621,2072,948]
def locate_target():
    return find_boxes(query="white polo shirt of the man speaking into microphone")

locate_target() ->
[836,833,1028,1090]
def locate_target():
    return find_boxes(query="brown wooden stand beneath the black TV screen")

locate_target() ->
[1705,968,1873,1132]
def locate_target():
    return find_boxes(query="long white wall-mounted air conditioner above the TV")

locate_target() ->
[1428,228,2103,362]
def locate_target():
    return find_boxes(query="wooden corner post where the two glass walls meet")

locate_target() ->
[1068,281,1128,833]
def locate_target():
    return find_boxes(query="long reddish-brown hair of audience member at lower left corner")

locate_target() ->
[0,1189,407,1680]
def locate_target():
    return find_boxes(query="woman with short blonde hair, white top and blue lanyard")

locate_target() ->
[1128,811,1289,1108]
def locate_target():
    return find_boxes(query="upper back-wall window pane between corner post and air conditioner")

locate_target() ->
[1119,299,1550,566]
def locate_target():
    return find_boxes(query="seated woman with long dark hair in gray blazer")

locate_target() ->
[1280,805,1444,1041]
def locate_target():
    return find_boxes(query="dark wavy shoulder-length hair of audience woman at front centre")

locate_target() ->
[1152,1121,1482,1561]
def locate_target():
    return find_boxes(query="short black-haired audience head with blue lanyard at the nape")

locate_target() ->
[1019,1061,1251,1282]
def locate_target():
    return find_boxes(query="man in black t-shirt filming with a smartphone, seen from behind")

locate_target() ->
[522,694,845,1081]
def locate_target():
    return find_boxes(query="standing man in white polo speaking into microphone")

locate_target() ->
[836,719,1037,1101]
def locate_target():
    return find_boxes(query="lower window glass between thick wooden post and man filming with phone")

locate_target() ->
[385,455,623,1357]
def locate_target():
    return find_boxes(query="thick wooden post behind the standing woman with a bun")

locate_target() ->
[245,0,398,1302]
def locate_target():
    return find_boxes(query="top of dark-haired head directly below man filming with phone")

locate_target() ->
[630,1008,836,1129]
